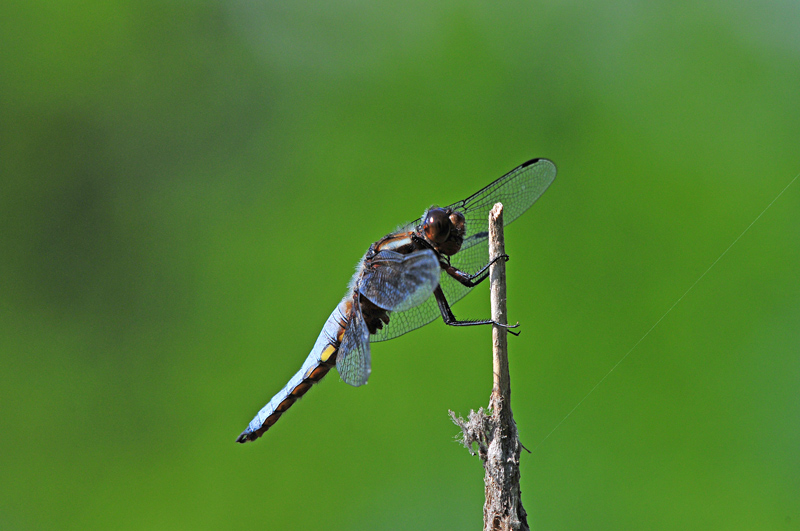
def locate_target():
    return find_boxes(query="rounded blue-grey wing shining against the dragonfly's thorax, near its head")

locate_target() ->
[359,249,441,312]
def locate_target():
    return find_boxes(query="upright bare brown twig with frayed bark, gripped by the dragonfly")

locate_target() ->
[450,203,529,531]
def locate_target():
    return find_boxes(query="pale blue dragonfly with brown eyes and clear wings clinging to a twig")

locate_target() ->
[236,158,556,443]
